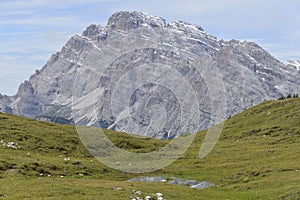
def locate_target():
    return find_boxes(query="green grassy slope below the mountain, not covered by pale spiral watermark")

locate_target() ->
[0,99,300,200]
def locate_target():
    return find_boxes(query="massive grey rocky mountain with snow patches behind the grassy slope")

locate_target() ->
[0,11,300,139]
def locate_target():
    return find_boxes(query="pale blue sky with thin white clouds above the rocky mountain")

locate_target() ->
[0,0,300,95]
